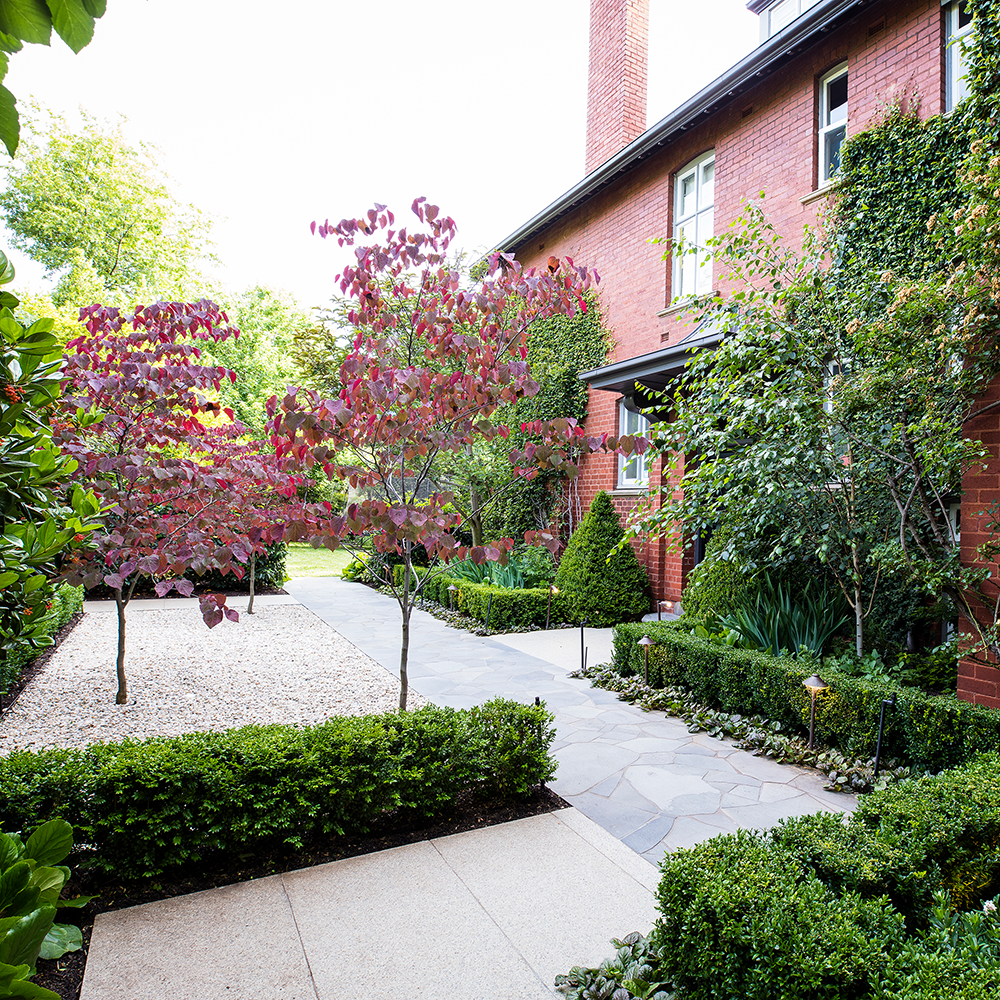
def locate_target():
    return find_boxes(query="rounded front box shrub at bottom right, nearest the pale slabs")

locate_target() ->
[653,830,903,1000]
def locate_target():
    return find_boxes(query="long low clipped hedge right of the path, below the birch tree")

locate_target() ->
[613,622,1000,771]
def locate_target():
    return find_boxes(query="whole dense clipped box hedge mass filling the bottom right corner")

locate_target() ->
[652,754,1000,1000]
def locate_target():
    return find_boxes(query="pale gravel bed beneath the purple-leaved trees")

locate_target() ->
[0,604,425,754]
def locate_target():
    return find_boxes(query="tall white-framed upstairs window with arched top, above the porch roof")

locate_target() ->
[672,151,715,299]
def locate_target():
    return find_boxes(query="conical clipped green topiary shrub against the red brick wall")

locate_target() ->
[556,492,650,628]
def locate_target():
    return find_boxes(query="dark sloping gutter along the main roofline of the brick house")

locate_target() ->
[496,0,870,253]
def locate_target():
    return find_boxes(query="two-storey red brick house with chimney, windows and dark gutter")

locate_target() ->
[499,0,1000,707]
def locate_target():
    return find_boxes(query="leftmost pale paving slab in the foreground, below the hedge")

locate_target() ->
[80,875,319,1000]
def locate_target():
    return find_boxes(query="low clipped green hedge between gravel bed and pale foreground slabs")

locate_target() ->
[0,699,556,877]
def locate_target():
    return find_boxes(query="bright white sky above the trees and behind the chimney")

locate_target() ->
[0,0,758,307]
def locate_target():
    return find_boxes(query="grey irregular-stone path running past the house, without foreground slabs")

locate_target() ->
[285,577,854,864]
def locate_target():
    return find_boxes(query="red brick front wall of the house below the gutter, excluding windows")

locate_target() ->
[518,0,944,599]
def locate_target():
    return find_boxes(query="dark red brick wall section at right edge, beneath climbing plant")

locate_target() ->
[958,379,1000,708]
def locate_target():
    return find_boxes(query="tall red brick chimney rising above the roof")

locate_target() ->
[586,0,649,174]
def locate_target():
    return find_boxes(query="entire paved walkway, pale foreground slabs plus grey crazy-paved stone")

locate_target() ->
[81,578,853,1000]
